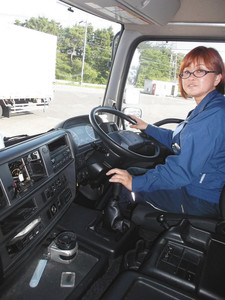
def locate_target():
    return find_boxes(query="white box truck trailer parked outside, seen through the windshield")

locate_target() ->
[0,25,57,117]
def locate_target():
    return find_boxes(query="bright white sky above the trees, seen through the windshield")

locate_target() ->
[0,0,119,33]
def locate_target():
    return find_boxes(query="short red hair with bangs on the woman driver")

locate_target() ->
[179,46,225,98]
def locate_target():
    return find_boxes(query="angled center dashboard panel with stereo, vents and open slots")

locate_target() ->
[0,130,76,280]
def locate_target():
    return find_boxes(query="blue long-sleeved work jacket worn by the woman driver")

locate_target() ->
[132,90,225,203]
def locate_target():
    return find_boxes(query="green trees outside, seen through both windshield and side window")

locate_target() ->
[15,17,183,88]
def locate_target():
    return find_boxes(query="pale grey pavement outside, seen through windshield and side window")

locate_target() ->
[0,85,194,136]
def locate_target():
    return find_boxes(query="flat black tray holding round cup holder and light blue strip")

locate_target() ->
[0,228,107,300]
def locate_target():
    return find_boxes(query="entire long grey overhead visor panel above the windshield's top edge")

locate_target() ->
[63,0,180,25]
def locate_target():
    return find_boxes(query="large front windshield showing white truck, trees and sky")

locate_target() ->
[0,0,120,137]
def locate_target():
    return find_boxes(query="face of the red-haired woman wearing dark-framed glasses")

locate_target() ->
[182,60,222,104]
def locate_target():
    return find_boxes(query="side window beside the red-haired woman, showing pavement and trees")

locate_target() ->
[123,41,225,129]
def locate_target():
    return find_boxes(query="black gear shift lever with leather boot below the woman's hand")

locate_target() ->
[104,183,130,233]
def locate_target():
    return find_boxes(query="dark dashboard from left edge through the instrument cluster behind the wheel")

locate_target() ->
[0,116,119,280]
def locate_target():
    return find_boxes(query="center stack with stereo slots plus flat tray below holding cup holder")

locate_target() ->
[0,130,135,300]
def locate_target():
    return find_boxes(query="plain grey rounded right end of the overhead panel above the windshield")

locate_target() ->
[117,0,180,25]
